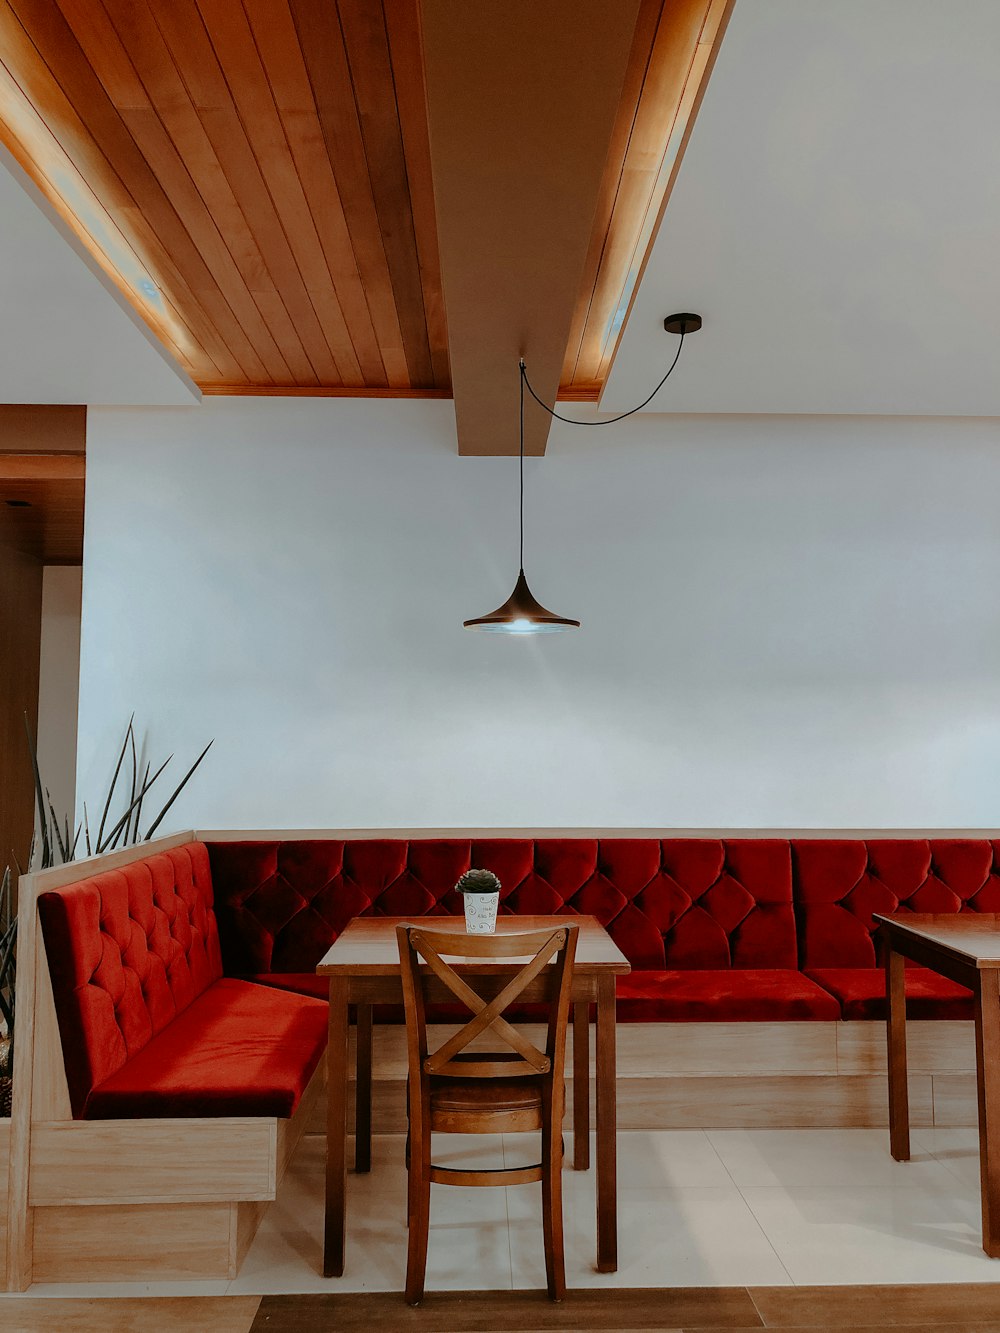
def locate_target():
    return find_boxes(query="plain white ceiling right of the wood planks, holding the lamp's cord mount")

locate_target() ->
[601,0,1000,416]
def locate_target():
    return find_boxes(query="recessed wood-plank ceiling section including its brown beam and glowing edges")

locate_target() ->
[0,0,733,426]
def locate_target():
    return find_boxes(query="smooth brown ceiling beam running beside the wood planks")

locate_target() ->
[421,0,639,455]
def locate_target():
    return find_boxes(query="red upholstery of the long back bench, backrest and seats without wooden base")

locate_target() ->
[208,837,1000,1022]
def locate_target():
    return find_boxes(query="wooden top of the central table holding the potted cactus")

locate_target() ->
[316,916,632,977]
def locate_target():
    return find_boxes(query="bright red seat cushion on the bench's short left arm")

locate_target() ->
[83,977,327,1120]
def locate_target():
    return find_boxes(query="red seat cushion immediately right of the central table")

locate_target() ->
[617,968,840,1022]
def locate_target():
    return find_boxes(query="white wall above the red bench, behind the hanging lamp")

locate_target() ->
[79,399,1000,828]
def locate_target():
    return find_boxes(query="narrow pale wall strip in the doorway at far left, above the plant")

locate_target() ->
[37,565,81,820]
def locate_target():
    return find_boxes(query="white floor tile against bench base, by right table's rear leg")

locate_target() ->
[705,1129,949,1189]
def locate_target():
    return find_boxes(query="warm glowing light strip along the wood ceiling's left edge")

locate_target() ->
[0,40,192,361]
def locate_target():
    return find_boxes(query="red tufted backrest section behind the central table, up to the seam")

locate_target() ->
[208,837,796,976]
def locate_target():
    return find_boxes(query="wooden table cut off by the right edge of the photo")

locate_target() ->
[875,913,1000,1258]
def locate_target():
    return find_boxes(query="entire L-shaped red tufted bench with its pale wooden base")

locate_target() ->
[8,833,1000,1286]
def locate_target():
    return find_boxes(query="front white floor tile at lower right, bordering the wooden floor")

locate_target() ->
[741,1177,1000,1285]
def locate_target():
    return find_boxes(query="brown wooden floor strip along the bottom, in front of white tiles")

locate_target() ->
[0,1282,1000,1333]
